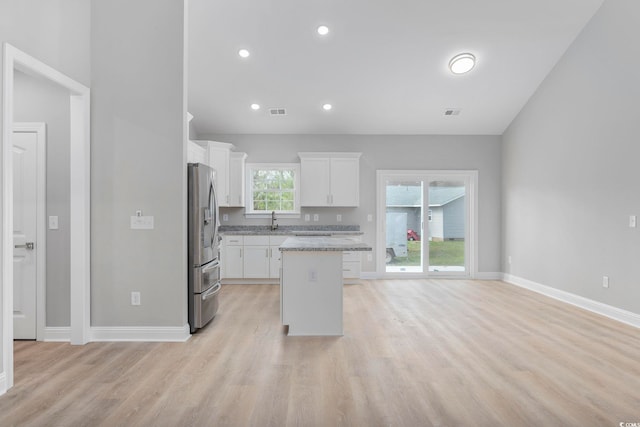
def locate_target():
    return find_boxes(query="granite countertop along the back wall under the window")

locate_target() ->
[218,225,364,237]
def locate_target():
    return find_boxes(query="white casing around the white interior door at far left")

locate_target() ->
[13,122,47,341]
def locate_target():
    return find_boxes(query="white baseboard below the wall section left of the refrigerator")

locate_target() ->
[91,324,191,342]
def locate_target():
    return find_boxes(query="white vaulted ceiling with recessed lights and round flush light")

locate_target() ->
[189,0,603,135]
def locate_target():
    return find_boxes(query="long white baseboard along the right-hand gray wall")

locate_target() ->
[502,273,640,328]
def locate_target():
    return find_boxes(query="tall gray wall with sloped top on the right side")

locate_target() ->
[503,0,640,313]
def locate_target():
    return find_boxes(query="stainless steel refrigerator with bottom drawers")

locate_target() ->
[188,163,221,333]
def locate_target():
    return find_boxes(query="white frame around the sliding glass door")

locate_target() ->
[376,170,478,279]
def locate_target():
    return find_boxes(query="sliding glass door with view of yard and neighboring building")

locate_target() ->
[377,171,477,277]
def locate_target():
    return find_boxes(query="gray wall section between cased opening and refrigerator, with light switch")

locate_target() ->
[91,0,187,327]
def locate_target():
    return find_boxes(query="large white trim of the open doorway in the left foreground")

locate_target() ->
[0,43,91,394]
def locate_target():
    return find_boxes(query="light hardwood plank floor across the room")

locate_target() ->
[0,280,640,427]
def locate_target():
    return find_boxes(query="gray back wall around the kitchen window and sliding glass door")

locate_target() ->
[200,135,501,273]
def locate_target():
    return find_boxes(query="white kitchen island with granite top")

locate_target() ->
[280,236,371,336]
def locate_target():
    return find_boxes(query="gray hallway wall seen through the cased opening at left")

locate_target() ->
[14,72,70,326]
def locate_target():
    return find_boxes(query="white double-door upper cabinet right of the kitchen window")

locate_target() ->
[298,153,362,207]
